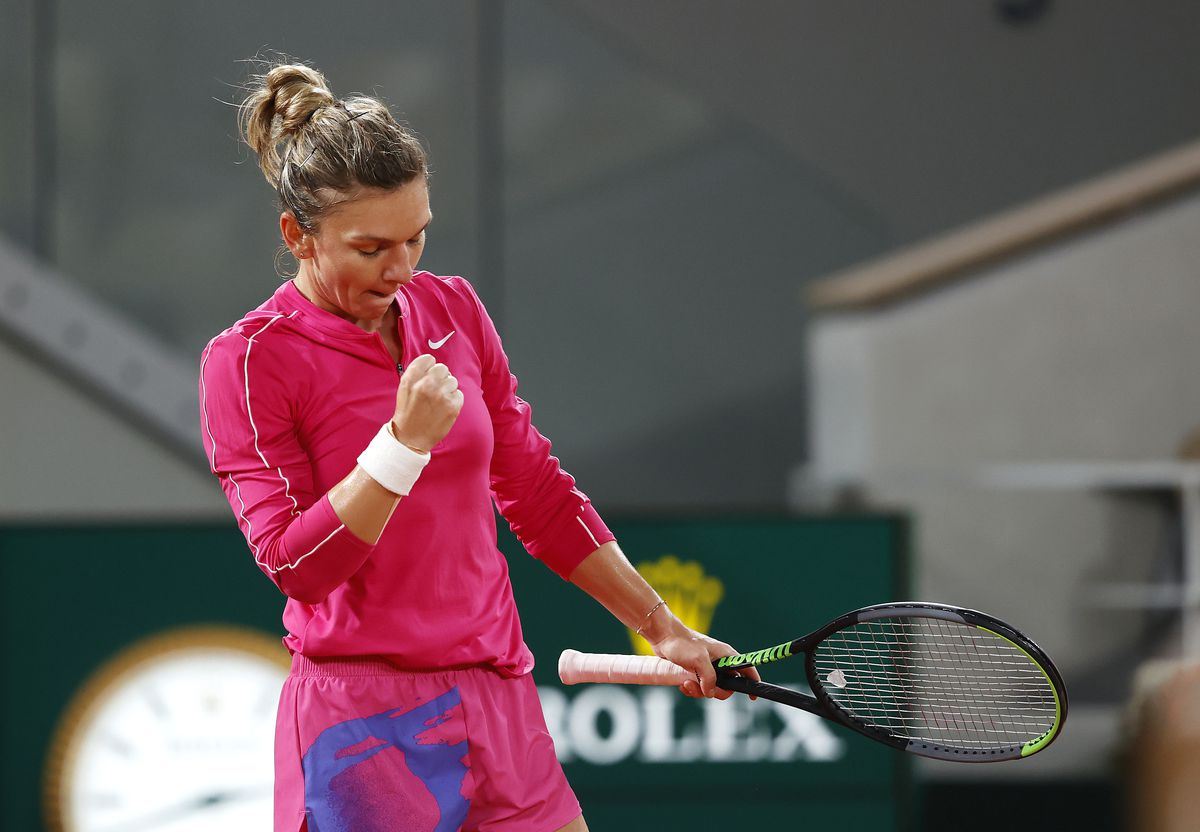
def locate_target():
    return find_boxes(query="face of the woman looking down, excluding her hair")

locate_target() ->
[280,178,433,331]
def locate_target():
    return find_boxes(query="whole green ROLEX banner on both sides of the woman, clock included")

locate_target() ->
[0,516,908,831]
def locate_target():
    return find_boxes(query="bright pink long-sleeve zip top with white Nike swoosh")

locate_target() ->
[200,271,613,676]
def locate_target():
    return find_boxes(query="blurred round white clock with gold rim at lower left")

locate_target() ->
[46,627,289,832]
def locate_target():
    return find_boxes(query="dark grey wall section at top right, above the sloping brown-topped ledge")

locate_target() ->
[568,0,1200,243]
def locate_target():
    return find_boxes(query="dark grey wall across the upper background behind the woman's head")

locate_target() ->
[0,0,1200,508]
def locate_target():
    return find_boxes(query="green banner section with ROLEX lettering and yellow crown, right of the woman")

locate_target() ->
[505,516,907,830]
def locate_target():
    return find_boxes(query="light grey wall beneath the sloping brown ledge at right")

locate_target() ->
[805,193,1200,771]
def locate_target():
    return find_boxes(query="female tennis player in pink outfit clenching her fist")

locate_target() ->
[200,65,755,832]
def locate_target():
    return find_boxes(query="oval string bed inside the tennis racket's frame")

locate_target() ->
[812,618,1057,750]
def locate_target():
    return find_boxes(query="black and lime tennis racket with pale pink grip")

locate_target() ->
[558,601,1067,762]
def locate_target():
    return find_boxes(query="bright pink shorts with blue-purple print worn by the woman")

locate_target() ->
[275,654,580,832]
